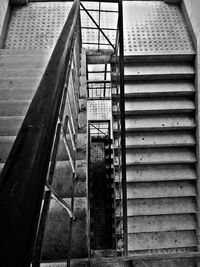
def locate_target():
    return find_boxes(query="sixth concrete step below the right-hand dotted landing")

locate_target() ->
[126,147,196,165]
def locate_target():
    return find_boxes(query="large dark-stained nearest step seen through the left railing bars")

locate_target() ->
[42,198,87,260]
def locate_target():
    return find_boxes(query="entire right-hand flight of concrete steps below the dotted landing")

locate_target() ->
[113,53,197,255]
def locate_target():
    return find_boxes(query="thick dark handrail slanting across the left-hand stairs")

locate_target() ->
[0,0,80,267]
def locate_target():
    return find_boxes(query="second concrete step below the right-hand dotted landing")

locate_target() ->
[122,81,195,98]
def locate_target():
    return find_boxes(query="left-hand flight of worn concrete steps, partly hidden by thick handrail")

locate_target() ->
[0,49,87,260]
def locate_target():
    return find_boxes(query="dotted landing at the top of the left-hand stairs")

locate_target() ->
[5,2,72,49]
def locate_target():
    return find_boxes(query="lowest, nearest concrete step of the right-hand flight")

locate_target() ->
[128,230,197,251]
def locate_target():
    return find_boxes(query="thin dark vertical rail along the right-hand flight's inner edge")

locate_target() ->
[116,0,128,256]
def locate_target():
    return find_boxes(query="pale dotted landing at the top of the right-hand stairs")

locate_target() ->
[124,1,193,55]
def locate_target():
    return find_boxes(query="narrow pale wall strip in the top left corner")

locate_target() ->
[0,0,10,48]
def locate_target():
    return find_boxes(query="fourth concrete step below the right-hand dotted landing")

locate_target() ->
[114,114,196,132]
